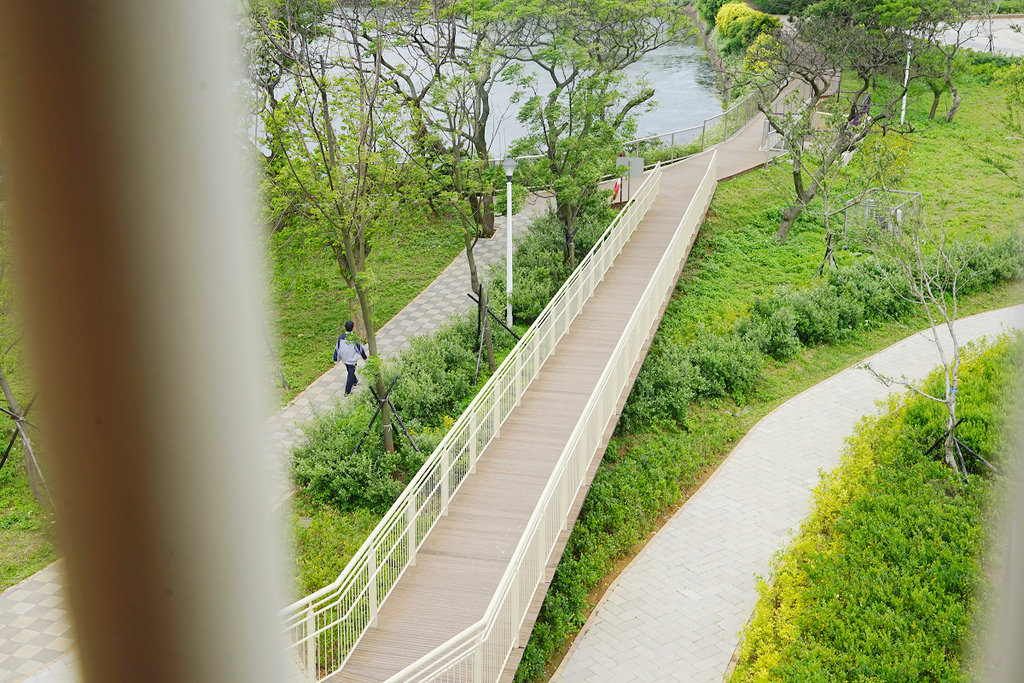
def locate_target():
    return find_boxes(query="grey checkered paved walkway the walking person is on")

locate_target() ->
[0,195,549,683]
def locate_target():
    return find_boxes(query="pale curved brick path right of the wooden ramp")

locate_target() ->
[552,305,1024,683]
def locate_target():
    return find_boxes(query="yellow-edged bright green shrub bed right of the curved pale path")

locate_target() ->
[730,335,1024,681]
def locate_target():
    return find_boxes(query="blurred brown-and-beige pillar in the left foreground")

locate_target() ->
[0,0,285,683]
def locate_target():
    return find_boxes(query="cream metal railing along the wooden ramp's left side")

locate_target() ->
[283,162,662,680]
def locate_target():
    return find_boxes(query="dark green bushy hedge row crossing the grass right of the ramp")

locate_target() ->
[617,236,1024,433]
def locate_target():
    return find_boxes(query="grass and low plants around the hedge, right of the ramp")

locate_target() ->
[517,72,1024,680]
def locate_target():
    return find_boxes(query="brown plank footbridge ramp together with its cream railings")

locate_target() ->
[284,109,778,682]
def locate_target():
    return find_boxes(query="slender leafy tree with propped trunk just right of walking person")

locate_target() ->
[254,1,420,451]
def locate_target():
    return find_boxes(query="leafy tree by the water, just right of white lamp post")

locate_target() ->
[514,0,691,265]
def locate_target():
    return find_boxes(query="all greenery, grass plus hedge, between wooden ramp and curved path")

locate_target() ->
[516,69,1022,681]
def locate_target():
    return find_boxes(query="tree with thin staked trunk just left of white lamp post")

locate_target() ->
[348,0,521,371]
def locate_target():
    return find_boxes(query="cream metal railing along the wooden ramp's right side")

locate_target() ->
[388,153,718,683]
